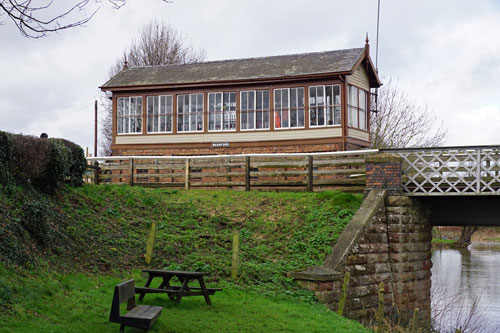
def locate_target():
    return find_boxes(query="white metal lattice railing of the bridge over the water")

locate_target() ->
[385,146,500,195]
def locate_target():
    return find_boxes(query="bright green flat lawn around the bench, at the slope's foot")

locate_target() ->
[0,270,369,332]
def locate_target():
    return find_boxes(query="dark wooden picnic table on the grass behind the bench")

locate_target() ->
[135,269,222,305]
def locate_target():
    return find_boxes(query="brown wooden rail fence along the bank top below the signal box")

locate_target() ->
[86,150,378,192]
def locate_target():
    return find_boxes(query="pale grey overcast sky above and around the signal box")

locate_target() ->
[0,0,500,151]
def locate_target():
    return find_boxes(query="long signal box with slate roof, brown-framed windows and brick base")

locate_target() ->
[101,42,381,156]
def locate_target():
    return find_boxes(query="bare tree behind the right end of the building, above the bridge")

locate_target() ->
[371,79,448,148]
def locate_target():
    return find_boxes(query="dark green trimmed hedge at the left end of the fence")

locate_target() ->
[0,131,86,193]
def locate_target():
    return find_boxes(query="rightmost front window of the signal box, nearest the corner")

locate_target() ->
[309,84,341,127]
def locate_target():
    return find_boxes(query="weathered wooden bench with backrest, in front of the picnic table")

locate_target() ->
[109,280,163,332]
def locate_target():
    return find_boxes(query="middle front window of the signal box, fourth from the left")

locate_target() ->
[208,92,236,131]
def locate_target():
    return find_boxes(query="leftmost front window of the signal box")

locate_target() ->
[117,97,142,134]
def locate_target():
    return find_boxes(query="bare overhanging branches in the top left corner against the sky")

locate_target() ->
[0,0,170,38]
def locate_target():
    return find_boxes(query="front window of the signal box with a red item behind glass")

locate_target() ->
[274,88,304,128]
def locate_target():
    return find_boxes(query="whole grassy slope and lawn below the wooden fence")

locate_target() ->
[0,186,368,332]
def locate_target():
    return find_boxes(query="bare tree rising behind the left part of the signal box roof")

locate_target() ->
[100,20,206,155]
